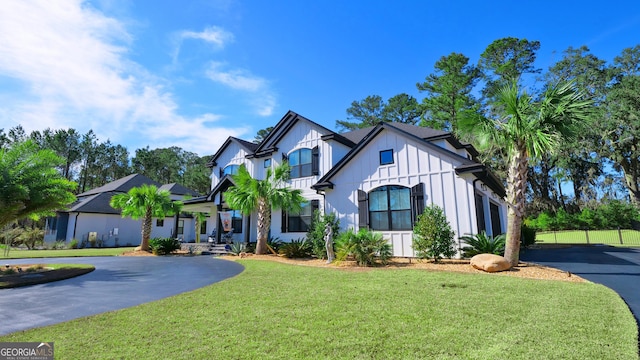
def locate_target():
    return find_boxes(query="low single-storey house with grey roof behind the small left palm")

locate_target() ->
[45,174,206,246]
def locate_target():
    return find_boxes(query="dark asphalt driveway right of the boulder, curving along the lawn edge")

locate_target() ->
[520,246,640,324]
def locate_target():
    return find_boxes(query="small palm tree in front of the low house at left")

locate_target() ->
[109,185,182,251]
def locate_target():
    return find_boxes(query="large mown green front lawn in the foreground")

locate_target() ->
[0,260,638,360]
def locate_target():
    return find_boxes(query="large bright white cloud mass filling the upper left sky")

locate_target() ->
[0,0,239,154]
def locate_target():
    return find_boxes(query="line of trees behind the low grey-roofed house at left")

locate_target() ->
[0,125,211,194]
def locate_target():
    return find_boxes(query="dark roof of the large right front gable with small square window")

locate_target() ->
[311,122,504,194]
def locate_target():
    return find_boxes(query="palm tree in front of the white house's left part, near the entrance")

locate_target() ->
[224,162,306,254]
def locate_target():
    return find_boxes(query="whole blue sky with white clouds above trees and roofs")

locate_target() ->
[0,0,640,155]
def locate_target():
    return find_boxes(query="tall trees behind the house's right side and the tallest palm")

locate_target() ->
[336,38,640,216]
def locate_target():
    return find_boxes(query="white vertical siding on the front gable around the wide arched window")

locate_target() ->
[325,130,488,256]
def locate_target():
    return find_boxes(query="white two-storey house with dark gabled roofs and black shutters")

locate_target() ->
[185,111,506,256]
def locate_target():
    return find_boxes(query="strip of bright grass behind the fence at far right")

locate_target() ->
[536,230,640,246]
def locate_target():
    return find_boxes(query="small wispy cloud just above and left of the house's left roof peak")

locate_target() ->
[206,61,277,116]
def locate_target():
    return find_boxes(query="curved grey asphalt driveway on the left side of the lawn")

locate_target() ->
[0,256,244,335]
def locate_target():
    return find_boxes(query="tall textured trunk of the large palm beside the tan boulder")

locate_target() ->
[504,144,528,266]
